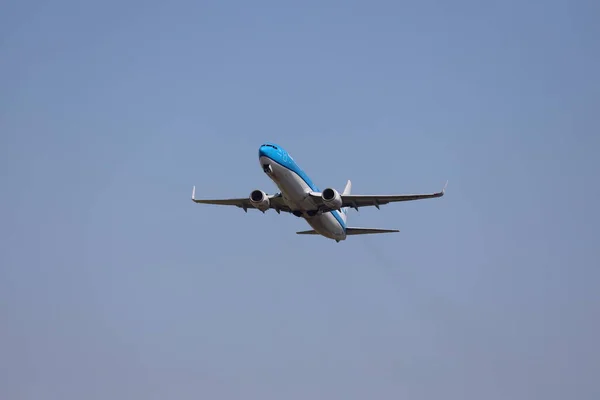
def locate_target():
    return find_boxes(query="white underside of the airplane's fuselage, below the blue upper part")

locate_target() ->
[259,157,346,240]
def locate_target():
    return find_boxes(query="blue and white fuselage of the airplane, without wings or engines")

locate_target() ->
[258,144,347,241]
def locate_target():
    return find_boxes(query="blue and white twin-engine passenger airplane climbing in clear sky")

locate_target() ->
[192,142,448,243]
